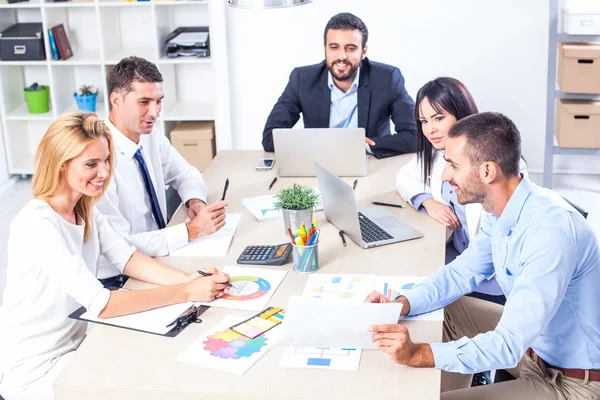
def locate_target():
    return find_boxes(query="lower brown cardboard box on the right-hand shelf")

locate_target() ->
[555,99,600,148]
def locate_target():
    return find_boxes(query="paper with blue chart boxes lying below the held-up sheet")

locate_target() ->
[279,347,362,371]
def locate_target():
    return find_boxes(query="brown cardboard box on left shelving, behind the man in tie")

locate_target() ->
[171,122,216,172]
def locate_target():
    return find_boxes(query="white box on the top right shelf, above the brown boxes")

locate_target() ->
[563,0,600,35]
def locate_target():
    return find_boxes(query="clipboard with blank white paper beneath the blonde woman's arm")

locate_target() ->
[69,303,210,337]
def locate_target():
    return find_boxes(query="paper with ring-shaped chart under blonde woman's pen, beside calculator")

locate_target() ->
[198,265,287,311]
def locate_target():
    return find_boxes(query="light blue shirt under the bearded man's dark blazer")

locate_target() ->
[327,68,360,128]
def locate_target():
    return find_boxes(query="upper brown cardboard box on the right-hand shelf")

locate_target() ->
[558,43,600,94]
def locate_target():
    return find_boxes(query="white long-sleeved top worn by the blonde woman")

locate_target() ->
[0,199,135,388]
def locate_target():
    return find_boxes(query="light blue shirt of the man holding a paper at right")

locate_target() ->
[406,178,600,373]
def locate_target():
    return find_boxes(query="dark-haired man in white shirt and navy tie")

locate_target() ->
[97,57,227,286]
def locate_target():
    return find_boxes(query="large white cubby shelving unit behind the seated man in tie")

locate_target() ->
[0,0,232,175]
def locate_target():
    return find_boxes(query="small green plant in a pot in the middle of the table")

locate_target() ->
[273,183,321,235]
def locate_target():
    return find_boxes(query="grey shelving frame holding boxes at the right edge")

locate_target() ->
[544,0,600,188]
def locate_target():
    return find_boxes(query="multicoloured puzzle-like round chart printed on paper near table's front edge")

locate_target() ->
[203,329,267,359]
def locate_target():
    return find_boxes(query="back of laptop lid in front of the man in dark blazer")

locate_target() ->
[273,128,368,176]
